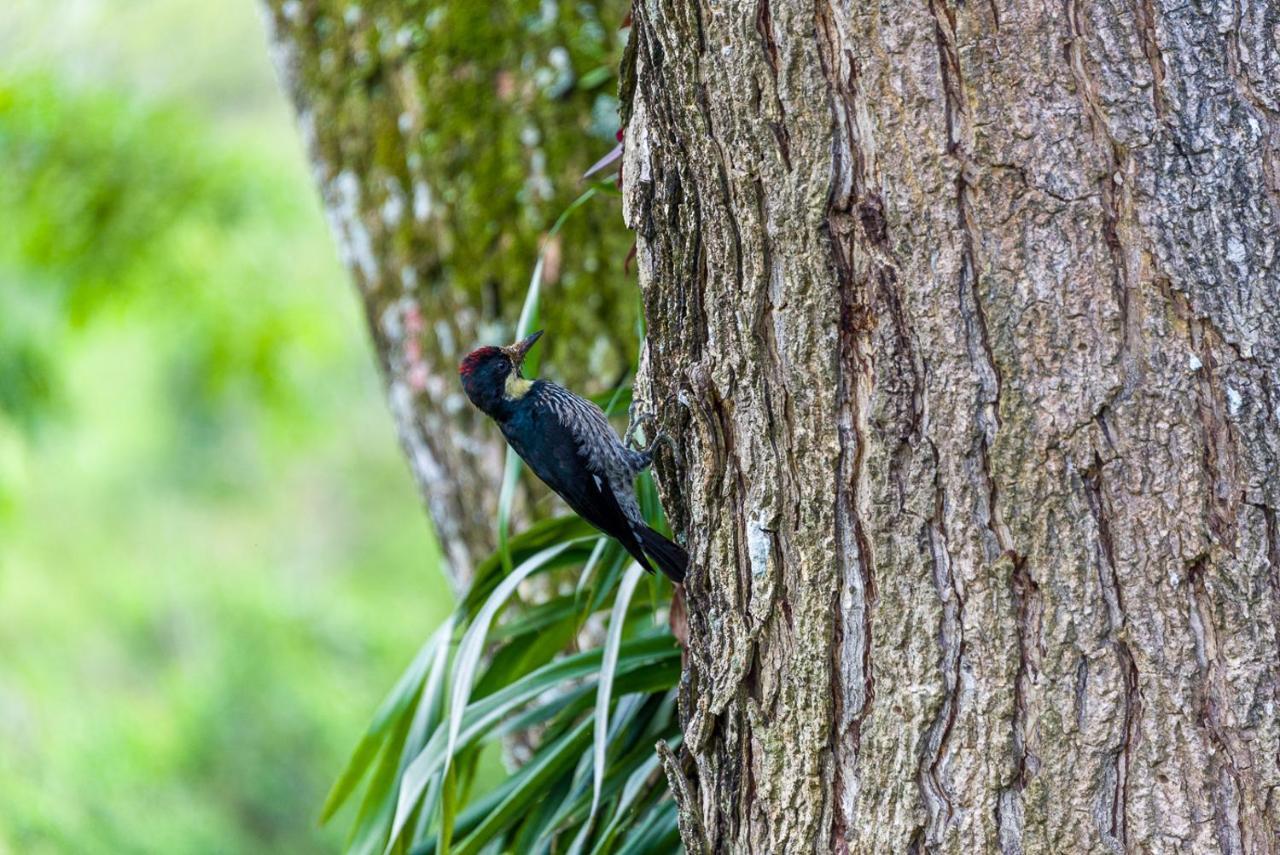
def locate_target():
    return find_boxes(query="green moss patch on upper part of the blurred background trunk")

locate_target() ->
[284,0,636,390]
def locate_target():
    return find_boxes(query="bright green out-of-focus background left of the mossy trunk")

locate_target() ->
[0,0,452,854]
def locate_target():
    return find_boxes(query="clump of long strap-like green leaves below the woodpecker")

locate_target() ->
[325,517,680,855]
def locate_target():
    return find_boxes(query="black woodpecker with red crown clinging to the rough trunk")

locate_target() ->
[458,330,689,582]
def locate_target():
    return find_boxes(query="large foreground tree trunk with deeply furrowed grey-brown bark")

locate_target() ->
[623,0,1280,854]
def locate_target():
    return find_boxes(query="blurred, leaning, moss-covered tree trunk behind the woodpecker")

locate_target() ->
[264,0,635,585]
